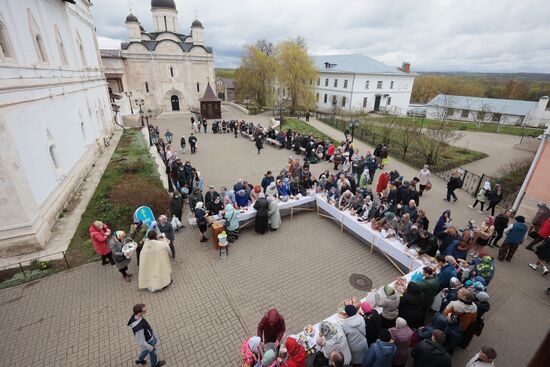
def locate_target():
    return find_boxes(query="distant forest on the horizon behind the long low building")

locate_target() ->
[411,73,550,103]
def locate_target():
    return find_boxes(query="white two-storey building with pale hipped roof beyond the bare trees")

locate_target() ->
[313,54,417,115]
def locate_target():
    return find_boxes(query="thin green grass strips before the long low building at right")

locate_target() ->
[366,116,544,136]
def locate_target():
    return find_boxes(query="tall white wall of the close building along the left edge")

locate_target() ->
[0,0,113,256]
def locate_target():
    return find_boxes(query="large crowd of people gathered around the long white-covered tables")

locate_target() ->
[90,119,550,367]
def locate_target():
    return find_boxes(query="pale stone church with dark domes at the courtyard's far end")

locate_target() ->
[101,0,215,114]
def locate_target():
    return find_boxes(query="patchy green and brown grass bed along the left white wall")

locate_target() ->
[67,129,169,266]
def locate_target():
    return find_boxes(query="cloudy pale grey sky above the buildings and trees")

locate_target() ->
[92,0,550,73]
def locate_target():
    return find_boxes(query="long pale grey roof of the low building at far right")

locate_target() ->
[428,94,538,116]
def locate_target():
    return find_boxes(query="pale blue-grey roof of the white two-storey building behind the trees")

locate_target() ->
[312,54,417,75]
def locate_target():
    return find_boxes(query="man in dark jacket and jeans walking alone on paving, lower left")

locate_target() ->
[127,303,166,367]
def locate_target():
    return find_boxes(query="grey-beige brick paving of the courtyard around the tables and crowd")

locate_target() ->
[0,110,550,367]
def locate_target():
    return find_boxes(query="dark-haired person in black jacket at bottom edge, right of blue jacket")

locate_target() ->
[411,330,452,367]
